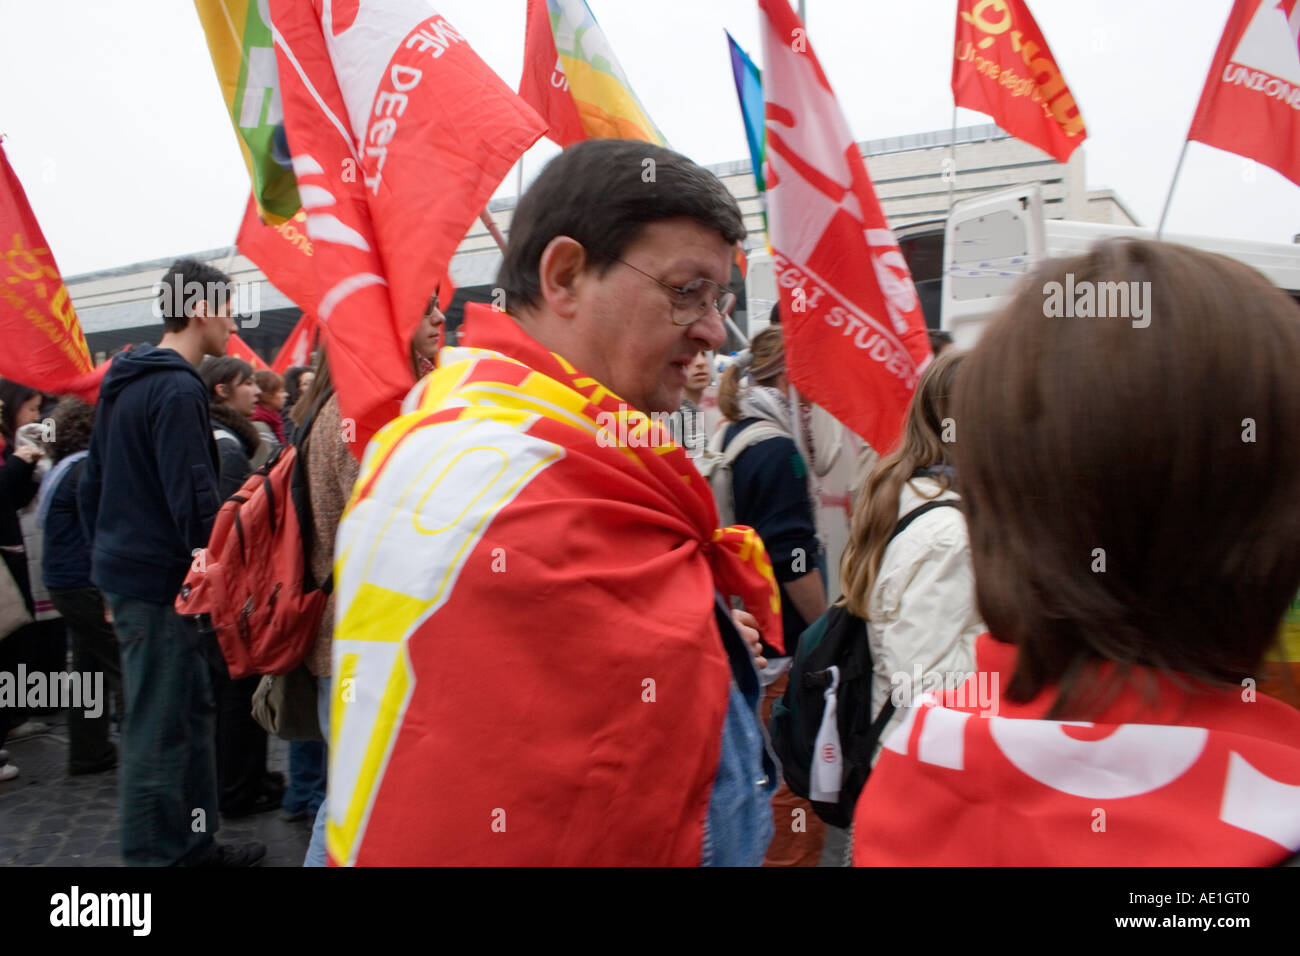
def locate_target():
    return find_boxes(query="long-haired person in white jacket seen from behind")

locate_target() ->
[840,350,984,761]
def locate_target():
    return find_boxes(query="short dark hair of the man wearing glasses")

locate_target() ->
[497,139,745,311]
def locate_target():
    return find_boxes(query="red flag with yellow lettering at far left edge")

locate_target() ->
[0,146,104,402]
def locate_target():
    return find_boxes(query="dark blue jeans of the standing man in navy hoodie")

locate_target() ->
[104,592,220,866]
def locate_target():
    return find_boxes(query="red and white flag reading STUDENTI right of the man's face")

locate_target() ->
[759,0,931,451]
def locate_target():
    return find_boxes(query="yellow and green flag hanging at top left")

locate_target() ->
[194,0,302,225]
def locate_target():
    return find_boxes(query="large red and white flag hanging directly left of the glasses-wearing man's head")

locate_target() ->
[270,0,545,451]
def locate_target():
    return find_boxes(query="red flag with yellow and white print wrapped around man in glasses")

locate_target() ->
[326,306,780,865]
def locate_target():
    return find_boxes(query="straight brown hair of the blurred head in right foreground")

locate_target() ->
[953,239,1300,717]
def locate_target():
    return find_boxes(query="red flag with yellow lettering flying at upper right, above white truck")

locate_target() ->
[953,0,1088,163]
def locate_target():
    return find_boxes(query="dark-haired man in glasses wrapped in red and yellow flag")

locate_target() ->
[326,139,783,865]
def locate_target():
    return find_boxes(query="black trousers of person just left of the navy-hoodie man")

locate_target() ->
[49,588,122,774]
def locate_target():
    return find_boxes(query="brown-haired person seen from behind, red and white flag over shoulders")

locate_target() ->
[854,239,1300,866]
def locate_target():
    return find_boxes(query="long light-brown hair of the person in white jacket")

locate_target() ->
[840,349,966,620]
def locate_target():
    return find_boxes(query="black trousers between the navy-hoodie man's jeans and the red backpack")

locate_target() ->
[209,652,278,816]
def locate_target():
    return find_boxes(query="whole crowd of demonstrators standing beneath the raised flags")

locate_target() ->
[0,140,1300,866]
